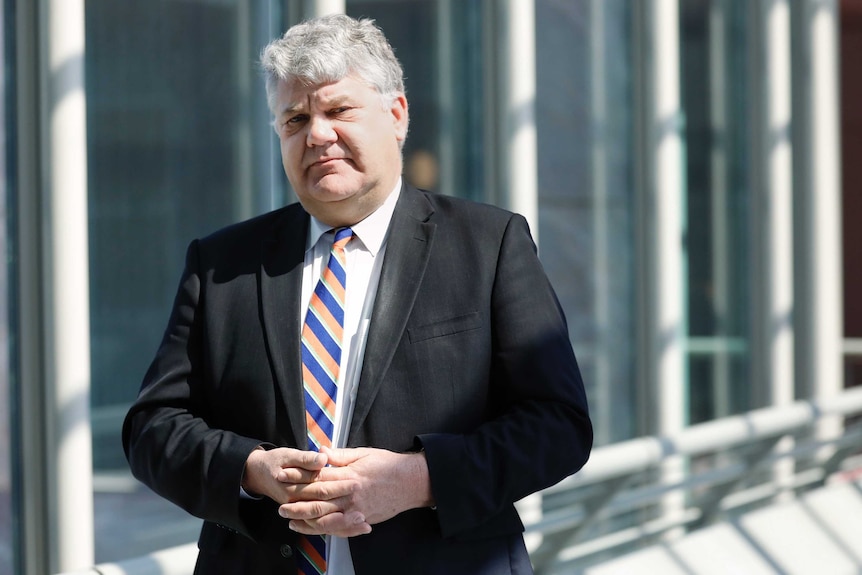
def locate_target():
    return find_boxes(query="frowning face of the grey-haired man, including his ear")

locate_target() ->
[275,76,407,227]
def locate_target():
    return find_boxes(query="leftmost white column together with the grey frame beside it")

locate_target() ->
[13,0,94,575]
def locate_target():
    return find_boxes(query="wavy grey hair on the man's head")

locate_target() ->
[260,14,404,113]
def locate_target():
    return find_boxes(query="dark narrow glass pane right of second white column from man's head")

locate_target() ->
[680,0,751,424]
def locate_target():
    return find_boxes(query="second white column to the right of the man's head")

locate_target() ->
[633,0,688,536]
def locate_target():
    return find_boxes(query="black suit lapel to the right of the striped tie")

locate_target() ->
[348,185,436,441]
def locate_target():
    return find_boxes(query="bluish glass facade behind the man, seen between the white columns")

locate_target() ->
[0,0,862,575]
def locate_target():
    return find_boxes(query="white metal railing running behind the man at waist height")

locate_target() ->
[57,388,862,575]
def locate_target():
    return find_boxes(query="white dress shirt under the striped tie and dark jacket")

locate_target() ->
[300,178,401,575]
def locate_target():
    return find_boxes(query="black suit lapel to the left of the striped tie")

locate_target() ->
[260,205,309,449]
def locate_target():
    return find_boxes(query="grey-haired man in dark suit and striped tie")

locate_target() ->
[123,16,592,575]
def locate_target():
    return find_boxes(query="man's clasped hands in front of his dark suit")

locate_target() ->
[243,447,433,537]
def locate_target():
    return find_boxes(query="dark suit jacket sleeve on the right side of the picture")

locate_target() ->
[418,215,593,536]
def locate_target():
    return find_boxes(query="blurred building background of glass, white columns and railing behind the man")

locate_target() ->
[0,0,862,575]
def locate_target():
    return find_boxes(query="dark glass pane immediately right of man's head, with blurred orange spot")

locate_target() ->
[347,0,487,200]
